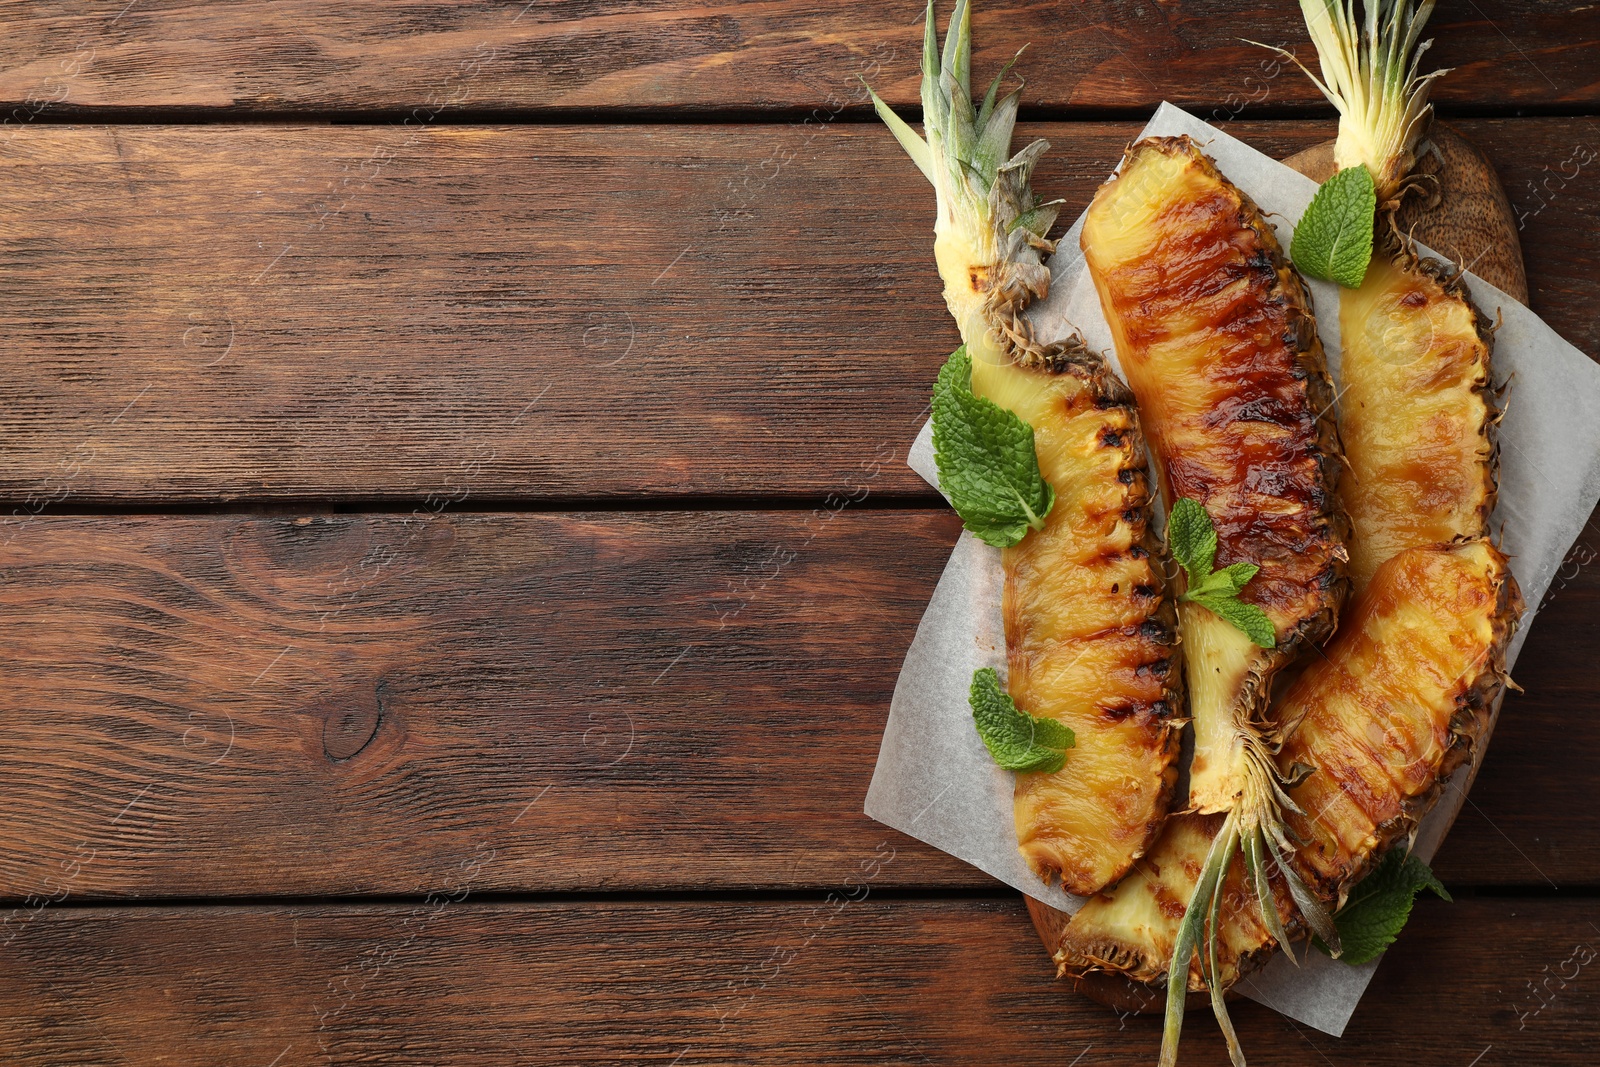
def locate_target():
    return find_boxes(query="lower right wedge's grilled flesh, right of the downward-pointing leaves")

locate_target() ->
[1277,539,1522,904]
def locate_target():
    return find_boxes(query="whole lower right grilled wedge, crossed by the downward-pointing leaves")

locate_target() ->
[1056,539,1522,990]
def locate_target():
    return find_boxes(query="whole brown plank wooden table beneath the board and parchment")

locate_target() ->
[0,0,1600,1067]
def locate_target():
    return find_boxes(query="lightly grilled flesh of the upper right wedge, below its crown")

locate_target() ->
[1339,254,1494,587]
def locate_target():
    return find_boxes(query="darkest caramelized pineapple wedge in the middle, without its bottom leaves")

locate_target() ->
[1082,138,1346,813]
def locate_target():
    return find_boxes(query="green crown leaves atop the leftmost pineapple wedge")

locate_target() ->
[867,0,1062,251]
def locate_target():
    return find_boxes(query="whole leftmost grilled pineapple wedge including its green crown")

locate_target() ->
[872,0,1182,894]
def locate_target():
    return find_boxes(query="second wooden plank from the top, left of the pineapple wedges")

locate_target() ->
[0,118,1600,514]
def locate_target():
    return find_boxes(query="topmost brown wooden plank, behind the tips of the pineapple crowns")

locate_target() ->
[0,0,1600,120]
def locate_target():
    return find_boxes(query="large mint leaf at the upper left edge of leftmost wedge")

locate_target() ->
[933,344,1056,549]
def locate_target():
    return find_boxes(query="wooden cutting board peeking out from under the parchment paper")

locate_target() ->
[1026,122,1528,1013]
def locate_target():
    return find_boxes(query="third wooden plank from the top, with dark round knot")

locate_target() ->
[0,511,1600,901]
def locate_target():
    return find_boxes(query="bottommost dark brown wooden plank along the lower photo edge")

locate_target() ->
[0,895,1600,1067]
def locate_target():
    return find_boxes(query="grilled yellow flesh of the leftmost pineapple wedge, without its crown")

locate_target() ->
[973,354,1181,894]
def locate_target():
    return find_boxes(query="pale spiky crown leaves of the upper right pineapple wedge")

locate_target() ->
[1250,0,1446,203]
